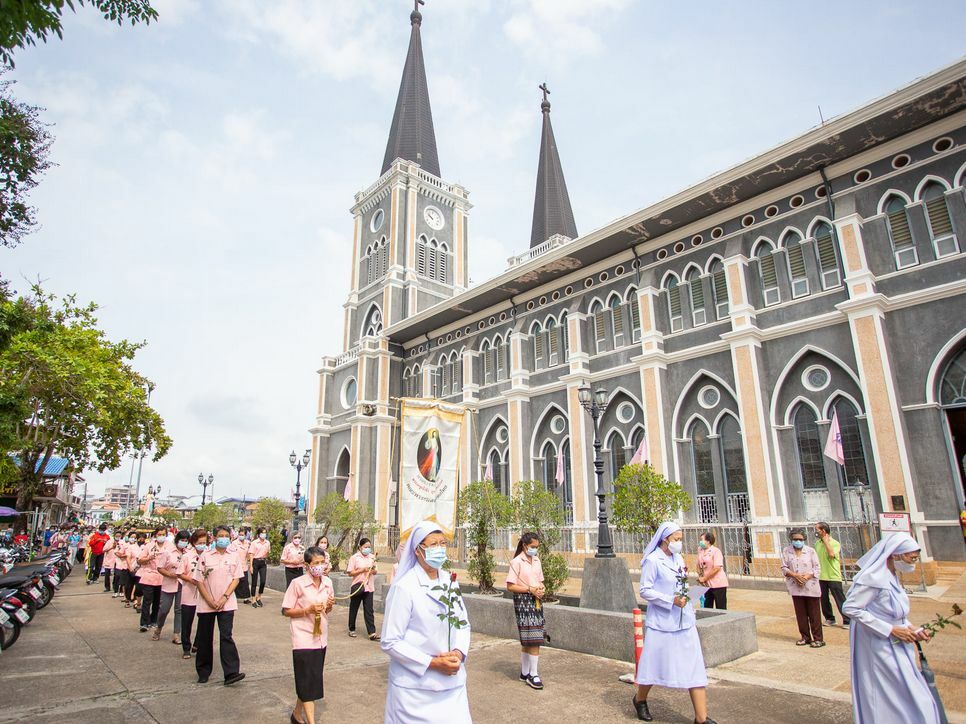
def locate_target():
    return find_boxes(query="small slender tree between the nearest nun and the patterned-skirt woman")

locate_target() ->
[459,480,513,593]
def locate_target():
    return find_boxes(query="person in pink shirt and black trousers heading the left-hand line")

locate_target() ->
[194,525,245,686]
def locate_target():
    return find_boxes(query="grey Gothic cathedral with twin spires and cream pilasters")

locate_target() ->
[308,5,966,561]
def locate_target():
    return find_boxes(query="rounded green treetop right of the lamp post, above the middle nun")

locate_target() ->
[611,464,691,537]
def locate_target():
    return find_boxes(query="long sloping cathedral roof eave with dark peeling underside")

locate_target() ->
[386,60,966,345]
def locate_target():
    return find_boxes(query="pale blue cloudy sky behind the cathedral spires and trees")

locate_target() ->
[0,0,966,498]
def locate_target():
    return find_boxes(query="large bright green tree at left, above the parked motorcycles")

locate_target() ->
[0,286,171,510]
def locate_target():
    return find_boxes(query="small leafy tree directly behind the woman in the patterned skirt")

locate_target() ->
[513,480,570,601]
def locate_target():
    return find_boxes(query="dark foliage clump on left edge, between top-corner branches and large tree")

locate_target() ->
[0,74,53,247]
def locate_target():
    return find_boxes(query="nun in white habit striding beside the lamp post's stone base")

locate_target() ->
[634,522,715,724]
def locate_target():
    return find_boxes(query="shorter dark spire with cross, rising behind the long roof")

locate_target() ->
[530,83,577,249]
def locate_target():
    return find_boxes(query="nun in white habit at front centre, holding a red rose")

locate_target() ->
[381,521,472,724]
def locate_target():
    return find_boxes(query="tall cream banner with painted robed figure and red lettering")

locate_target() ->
[399,399,464,539]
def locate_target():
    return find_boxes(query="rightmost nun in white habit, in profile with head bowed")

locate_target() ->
[842,533,940,724]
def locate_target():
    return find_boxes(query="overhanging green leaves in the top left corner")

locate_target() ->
[0,0,158,67]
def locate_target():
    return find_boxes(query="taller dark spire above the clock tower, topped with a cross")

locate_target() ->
[382,0,440,176]
